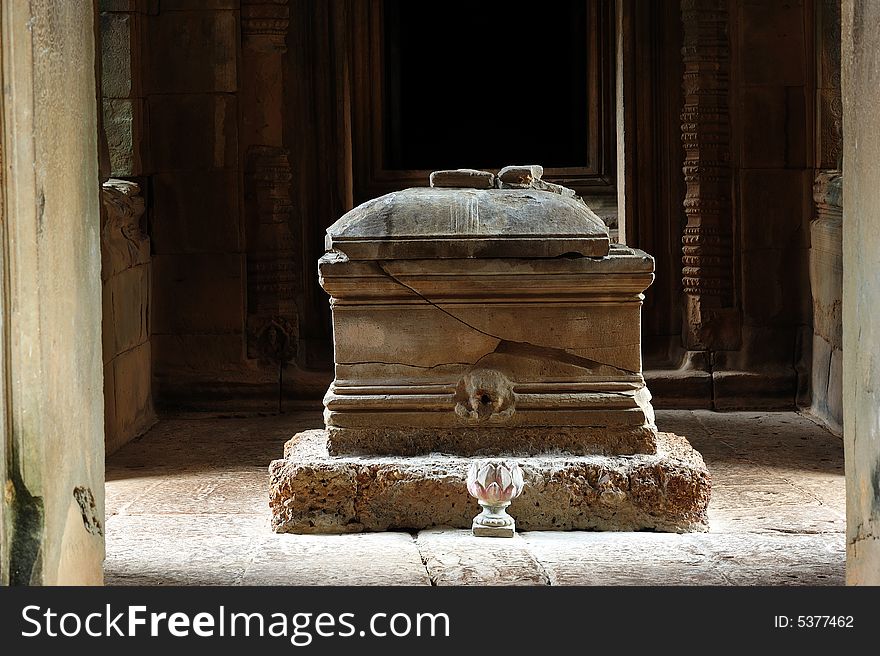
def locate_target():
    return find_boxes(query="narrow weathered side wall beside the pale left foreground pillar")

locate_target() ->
[99,0,155,454]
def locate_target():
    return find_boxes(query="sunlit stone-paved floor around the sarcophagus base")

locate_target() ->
[106,411,845,585]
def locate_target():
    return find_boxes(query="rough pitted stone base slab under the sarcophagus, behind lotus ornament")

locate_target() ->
[269,430,711,533]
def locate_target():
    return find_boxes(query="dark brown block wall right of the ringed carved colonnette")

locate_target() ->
[712,0,813,409]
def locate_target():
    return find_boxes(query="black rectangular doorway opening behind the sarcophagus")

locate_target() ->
[383,0,592,170]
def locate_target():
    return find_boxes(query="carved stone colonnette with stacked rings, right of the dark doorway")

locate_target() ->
[681,0,740,350]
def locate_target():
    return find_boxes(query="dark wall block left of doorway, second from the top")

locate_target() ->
[149,94,238,172]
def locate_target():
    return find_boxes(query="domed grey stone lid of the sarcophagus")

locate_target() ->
[326,184,610,260]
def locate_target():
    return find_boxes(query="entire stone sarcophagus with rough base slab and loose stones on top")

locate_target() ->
[270,167,709,532]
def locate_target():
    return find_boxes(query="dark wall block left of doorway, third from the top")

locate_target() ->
[150,170,241,253]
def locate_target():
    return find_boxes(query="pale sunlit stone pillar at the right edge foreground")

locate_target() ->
[841,0,880,585]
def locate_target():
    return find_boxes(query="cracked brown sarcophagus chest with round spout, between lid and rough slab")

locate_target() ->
[319,249,653,454]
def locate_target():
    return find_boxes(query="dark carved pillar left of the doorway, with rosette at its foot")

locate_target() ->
[239,0,300,362]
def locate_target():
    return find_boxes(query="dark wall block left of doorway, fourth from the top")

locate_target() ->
[153,254,244,334]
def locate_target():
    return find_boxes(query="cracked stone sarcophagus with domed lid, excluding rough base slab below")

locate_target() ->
[319,179,656,455]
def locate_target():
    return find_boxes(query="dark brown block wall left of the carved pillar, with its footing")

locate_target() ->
[140,0,278,412]
